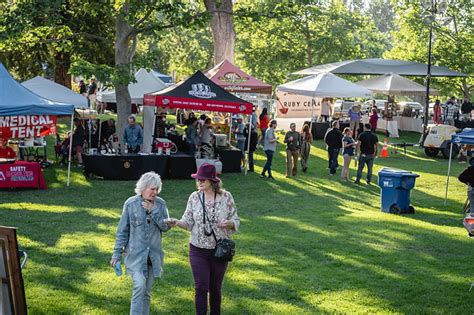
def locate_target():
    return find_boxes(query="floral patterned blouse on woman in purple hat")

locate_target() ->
[181,191,240,249]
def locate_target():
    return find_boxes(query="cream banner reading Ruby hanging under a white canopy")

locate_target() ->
[276,91,322,118]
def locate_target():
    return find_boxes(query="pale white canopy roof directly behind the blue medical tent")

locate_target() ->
[22,76,88,108]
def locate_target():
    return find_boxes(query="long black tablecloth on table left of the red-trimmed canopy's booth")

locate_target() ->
[82,154,169,180]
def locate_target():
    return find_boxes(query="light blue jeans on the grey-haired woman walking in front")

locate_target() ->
[130,265,155,315]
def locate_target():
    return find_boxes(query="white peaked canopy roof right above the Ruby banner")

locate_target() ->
[277,73,372,97]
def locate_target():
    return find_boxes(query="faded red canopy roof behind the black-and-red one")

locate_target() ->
[206,59,272,94]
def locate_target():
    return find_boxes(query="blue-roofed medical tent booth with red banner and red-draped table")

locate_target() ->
[0,64,74,188]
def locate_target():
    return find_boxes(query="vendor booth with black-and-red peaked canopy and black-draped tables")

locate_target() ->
[83,71,252,180]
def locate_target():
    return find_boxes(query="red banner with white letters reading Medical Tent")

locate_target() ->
[0,115,56,139]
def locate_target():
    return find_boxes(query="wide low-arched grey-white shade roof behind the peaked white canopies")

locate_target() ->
[293,58,468,77]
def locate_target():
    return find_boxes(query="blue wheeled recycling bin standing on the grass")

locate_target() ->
[378,167,420,213]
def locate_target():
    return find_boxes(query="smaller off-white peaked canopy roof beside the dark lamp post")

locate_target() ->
[356,73,438,95]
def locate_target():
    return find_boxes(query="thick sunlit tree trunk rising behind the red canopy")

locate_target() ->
[204,0,235,64]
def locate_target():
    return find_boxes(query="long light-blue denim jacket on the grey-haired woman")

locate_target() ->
[112,196,170,278]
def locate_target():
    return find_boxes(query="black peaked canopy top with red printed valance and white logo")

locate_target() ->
[143,71,252,114]
